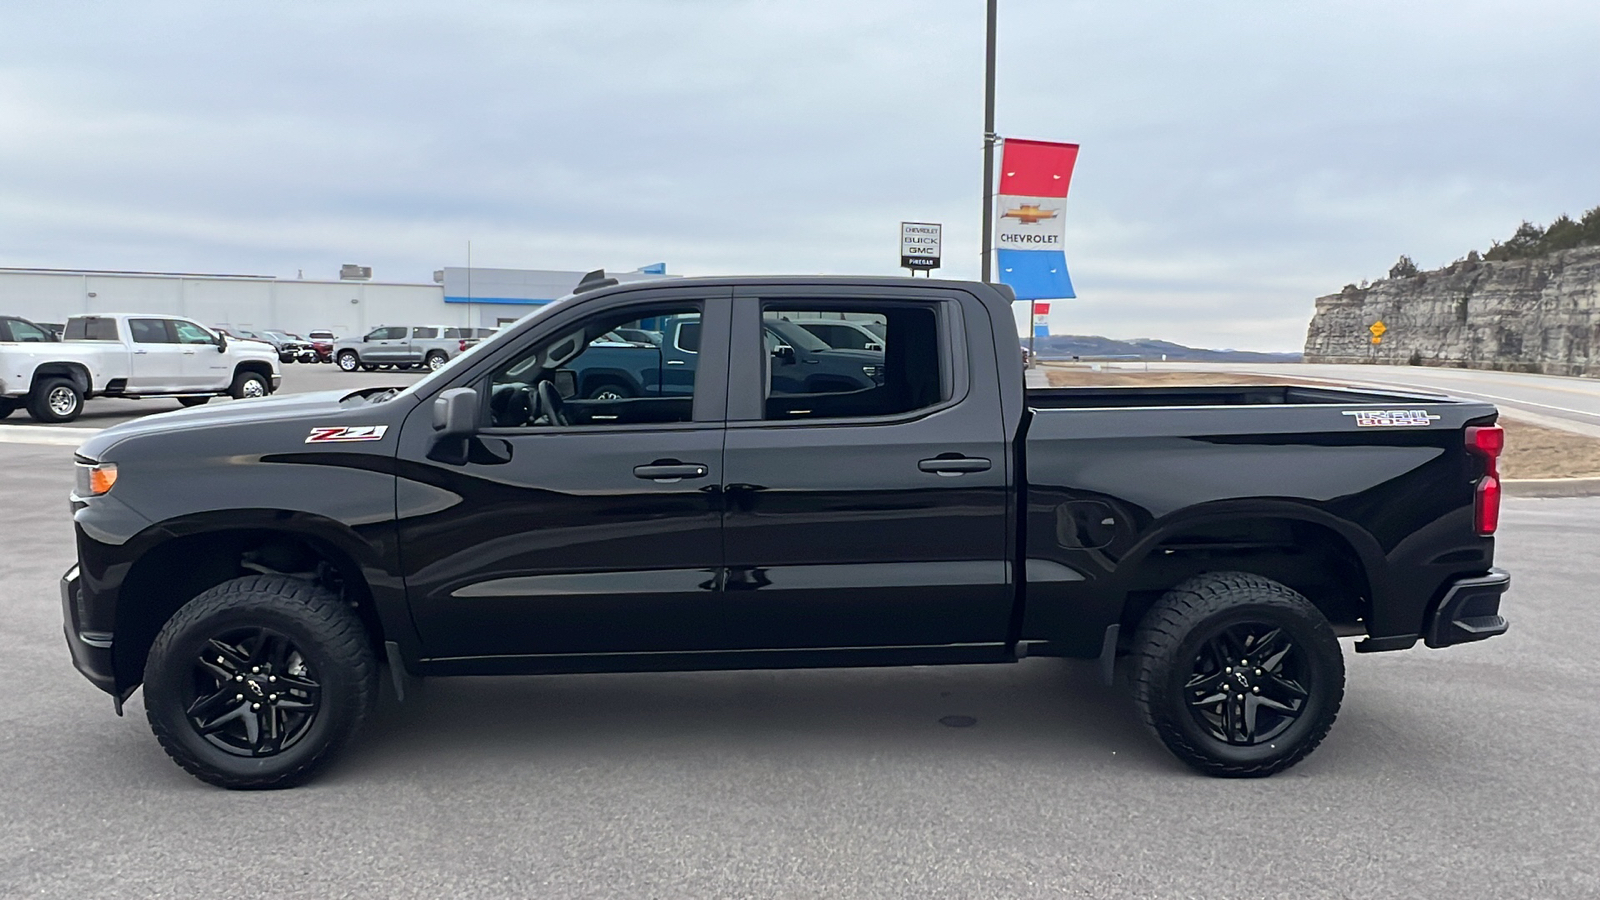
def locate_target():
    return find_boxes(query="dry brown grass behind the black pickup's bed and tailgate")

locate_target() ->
[1043,365,1600,479]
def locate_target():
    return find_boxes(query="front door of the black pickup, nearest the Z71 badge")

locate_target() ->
[397,288,728,668]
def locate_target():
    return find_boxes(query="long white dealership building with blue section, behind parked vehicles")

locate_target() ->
[0,264,667,336]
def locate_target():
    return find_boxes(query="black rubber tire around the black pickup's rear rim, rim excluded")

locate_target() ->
[1131,572,1344,778]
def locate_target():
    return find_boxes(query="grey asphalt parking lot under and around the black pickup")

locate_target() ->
[0,432,1600,900]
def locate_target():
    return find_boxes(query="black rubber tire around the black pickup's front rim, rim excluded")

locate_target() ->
[144,575,379,790]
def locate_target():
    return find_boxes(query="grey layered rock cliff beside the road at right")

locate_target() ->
[1306,247,1600,376]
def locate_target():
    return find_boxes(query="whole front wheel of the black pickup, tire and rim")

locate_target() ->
[144,575,378,790]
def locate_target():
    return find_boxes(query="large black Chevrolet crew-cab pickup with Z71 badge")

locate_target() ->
[61,277,1509,788]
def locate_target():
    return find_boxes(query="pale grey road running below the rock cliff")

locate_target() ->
[1126,362,1600,437]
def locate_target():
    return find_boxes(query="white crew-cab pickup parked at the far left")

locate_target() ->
[0,312,282,423]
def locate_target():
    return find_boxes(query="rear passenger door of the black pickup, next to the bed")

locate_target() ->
[723,287,1013,646]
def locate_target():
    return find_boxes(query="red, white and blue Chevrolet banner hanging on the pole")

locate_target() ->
[994,138,1078,299]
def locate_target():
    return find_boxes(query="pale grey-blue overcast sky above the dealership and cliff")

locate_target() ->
[0,0,1600,351]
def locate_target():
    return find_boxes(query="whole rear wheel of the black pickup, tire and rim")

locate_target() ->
[1133,572,1344,778]
